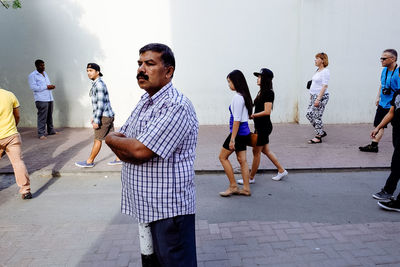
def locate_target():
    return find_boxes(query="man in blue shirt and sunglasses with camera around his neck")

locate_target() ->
[359,49,400,153]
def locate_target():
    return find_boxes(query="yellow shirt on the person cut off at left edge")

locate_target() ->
[0,89,19,139]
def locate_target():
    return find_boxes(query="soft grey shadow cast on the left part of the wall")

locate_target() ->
[0,0,103,127]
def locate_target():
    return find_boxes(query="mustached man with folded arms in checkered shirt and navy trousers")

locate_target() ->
[106,43,198,267]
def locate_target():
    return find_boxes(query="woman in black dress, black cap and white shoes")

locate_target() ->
[238,68,288,184]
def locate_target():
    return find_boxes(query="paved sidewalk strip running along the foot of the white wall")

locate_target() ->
[0,124,393,174]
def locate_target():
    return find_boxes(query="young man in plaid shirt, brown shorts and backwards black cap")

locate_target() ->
[75,63,122,168]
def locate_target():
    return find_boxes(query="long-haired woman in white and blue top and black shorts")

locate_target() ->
[219,70,253,197]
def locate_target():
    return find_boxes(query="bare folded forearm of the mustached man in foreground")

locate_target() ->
[105,132,157,164]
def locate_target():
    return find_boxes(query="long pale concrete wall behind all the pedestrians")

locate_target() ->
[0,0,400,127]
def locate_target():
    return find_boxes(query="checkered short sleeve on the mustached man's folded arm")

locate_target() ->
[137,105,191,159]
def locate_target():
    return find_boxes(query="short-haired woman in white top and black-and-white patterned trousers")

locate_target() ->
[306,53,330,144]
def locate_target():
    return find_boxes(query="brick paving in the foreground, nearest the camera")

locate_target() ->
[0,220,400,267]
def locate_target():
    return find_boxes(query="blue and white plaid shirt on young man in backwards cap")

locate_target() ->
[89,77,114,124]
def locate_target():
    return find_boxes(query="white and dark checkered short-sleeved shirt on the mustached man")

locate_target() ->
[120,82,199,223]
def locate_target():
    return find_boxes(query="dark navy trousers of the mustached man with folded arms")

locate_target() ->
[150,214,197,267]
